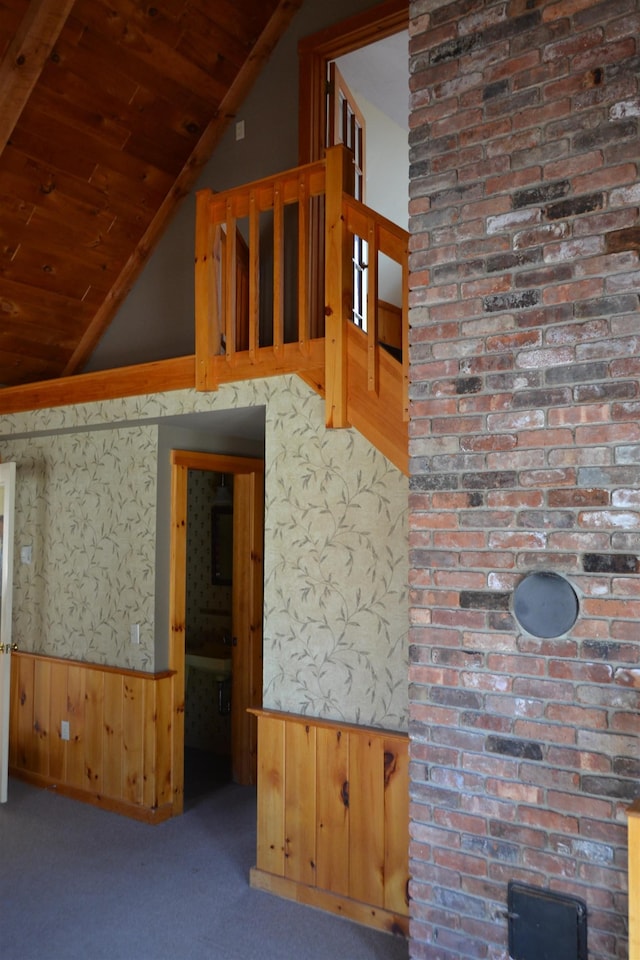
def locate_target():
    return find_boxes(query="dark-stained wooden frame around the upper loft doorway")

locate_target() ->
[298,0,409,164]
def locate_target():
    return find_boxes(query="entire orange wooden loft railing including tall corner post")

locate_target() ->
[196,146,409,466]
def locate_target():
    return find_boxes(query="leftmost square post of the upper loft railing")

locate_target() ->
[195,190,220,390]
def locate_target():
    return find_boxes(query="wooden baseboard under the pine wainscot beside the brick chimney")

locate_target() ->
[250,867,409,937]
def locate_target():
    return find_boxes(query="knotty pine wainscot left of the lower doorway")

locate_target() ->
[9,652,173,822]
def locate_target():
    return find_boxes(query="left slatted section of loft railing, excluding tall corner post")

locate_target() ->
[196,156,325,390]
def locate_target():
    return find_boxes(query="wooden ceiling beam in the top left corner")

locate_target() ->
[0,0,75,155]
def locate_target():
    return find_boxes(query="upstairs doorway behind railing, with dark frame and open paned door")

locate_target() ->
[299,0,409,352]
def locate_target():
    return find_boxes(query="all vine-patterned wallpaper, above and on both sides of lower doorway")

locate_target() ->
[0,376,408,729]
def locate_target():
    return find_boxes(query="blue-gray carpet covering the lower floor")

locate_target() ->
[0,779,408,960]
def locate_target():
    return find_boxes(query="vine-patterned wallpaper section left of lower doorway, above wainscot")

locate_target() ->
[2,426,157,670]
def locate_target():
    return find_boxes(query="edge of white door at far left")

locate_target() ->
[0,463,16,803]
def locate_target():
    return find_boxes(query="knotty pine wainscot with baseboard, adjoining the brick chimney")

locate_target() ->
[251,710,409,934]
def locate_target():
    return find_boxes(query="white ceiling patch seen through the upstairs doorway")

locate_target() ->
[336,30,409,130]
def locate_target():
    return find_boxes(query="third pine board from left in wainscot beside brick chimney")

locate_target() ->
[316,727,350,896]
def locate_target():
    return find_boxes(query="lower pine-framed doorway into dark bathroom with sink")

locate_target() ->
[169,450,264,814]
